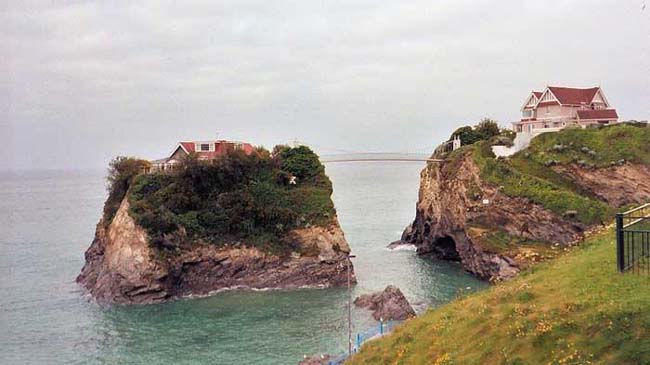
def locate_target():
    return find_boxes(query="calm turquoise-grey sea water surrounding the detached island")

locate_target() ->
[0,163,485,365]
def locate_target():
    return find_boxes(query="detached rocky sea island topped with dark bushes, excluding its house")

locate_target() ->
[77,146,355,304]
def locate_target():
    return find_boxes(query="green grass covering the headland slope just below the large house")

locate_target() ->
[466,124,650,225]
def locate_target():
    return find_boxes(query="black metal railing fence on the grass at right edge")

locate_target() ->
[616,203,650,274]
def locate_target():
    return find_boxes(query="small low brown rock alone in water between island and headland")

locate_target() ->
[354,285,415,321]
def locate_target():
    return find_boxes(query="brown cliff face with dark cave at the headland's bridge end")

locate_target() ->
[401,153,585,280]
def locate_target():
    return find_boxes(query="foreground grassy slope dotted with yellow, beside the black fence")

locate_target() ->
[348,229,650,365]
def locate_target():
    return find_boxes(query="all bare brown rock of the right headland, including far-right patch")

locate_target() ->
[401,149,650,280]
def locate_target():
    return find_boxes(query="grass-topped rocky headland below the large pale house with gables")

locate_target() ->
[401,124,650,280]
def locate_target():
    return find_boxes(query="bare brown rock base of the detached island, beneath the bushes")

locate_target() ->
[77,199,356,304]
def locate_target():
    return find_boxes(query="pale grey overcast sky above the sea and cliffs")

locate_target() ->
[0,0,650,170]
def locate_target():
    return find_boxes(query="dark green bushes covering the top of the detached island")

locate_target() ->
[102,146,336,252]
